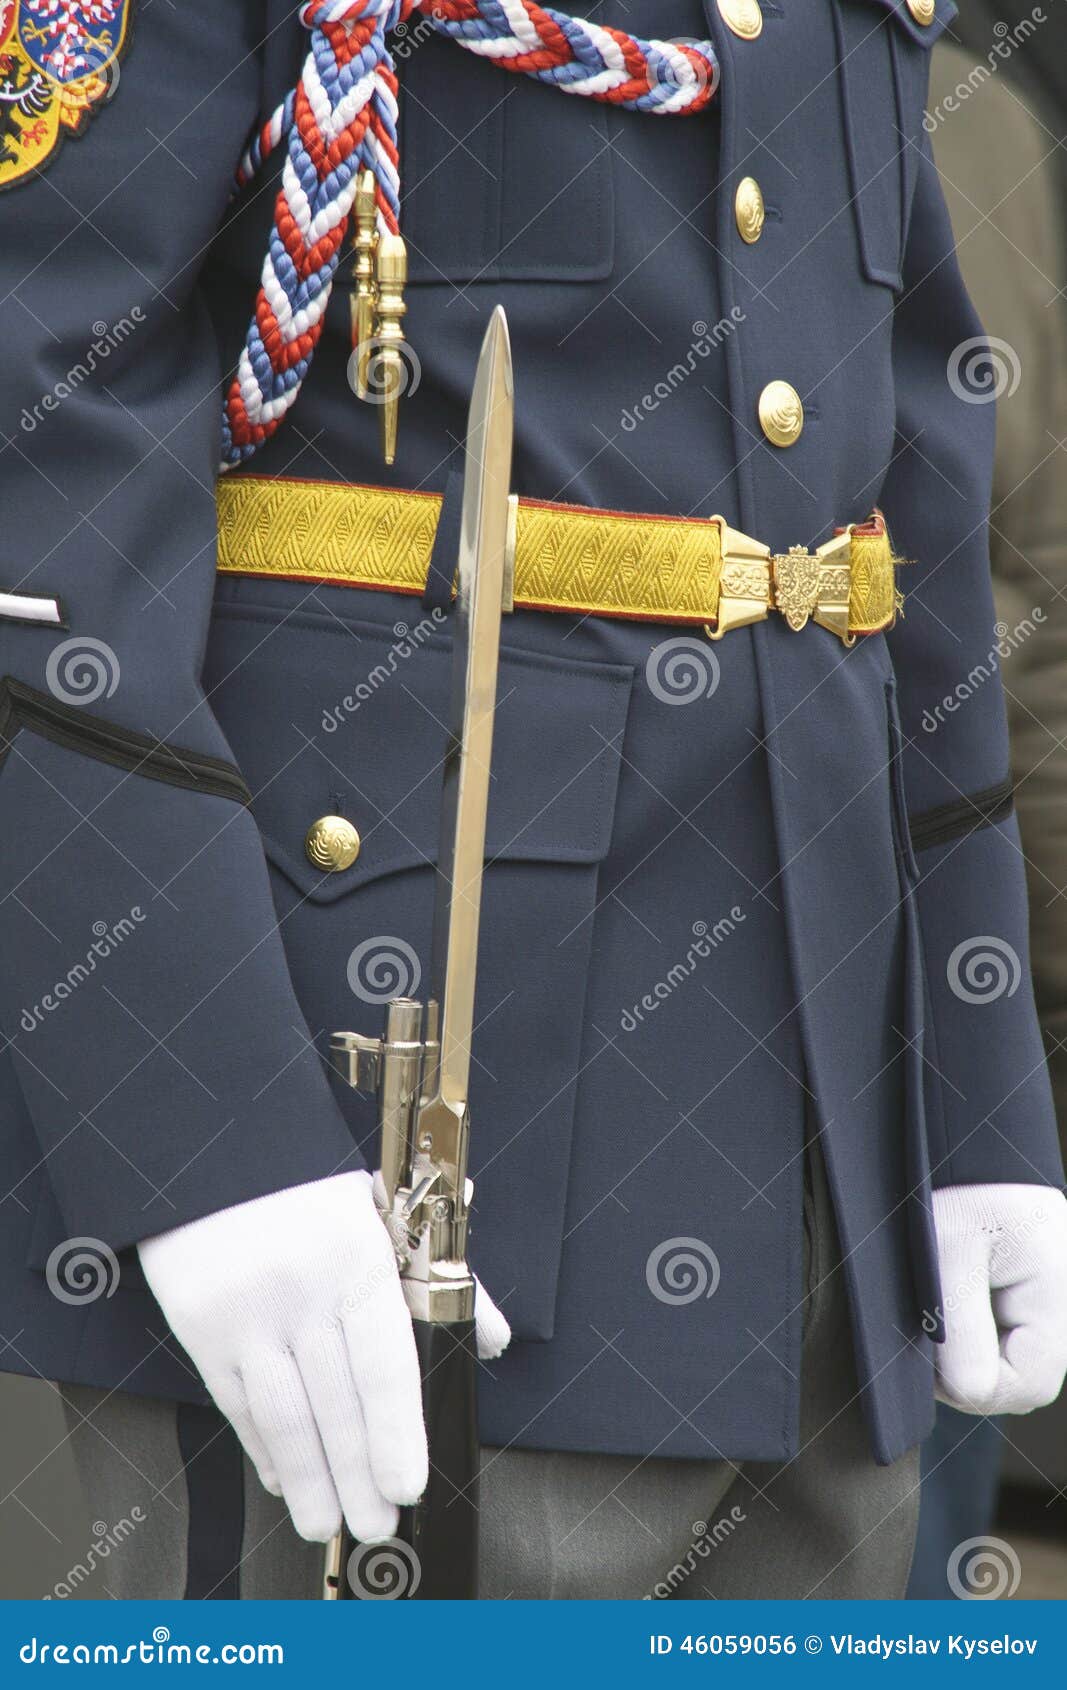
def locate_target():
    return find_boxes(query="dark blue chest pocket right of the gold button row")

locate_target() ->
[834,0,957,289]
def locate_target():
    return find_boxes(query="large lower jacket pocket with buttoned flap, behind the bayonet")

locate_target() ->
[205,593,632,1338]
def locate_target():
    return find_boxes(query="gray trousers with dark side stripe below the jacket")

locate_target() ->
[63,1156,918,1600]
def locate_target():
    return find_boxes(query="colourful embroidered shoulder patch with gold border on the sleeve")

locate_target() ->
[0,0,134,189]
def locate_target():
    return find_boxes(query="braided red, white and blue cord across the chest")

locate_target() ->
[220,0,719,470]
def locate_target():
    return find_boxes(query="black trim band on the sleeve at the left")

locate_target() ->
[0,674,252,804]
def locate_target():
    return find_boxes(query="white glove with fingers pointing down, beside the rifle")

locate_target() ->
[137,1173,428,1543]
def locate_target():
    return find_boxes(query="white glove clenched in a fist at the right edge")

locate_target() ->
[933,1185,1067,1415]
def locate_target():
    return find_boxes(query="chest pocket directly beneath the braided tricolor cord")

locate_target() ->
[401,41,614,284]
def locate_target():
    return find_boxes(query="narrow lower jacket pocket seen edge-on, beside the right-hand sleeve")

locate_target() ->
[886,681,944,1342]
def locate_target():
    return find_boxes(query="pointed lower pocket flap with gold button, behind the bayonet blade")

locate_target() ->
[205,607,631,902]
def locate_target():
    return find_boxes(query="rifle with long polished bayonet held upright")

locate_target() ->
[325,306,514,1600]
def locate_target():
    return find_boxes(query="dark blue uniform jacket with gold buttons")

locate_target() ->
[0,0,1062,1460]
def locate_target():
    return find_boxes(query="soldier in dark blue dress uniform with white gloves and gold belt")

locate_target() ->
[0,0,1067,1599]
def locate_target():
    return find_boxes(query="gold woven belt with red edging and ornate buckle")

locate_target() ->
[218,475,901,646]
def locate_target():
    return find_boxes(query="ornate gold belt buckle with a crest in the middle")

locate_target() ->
[705,517,856,646]
